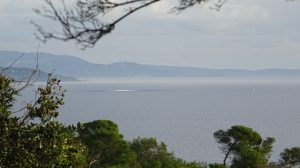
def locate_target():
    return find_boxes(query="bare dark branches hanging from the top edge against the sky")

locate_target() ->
[32,0,219,49]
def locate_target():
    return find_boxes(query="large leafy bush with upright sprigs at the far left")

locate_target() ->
[0,75,84,168]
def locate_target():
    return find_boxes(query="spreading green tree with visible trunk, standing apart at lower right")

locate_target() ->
[214,125,275,168]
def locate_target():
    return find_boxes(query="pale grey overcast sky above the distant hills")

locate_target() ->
[0,0,300,69]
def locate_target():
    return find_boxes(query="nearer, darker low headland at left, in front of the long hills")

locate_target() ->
[0,67,78,82]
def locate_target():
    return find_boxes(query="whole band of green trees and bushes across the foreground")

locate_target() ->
[0,75,300,168]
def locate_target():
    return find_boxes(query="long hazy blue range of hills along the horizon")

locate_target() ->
[0,51,300,77]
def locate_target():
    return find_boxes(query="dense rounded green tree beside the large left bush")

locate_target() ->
[78,120,135,168]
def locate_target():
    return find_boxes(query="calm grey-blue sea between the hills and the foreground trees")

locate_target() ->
[28,78,300,162]
